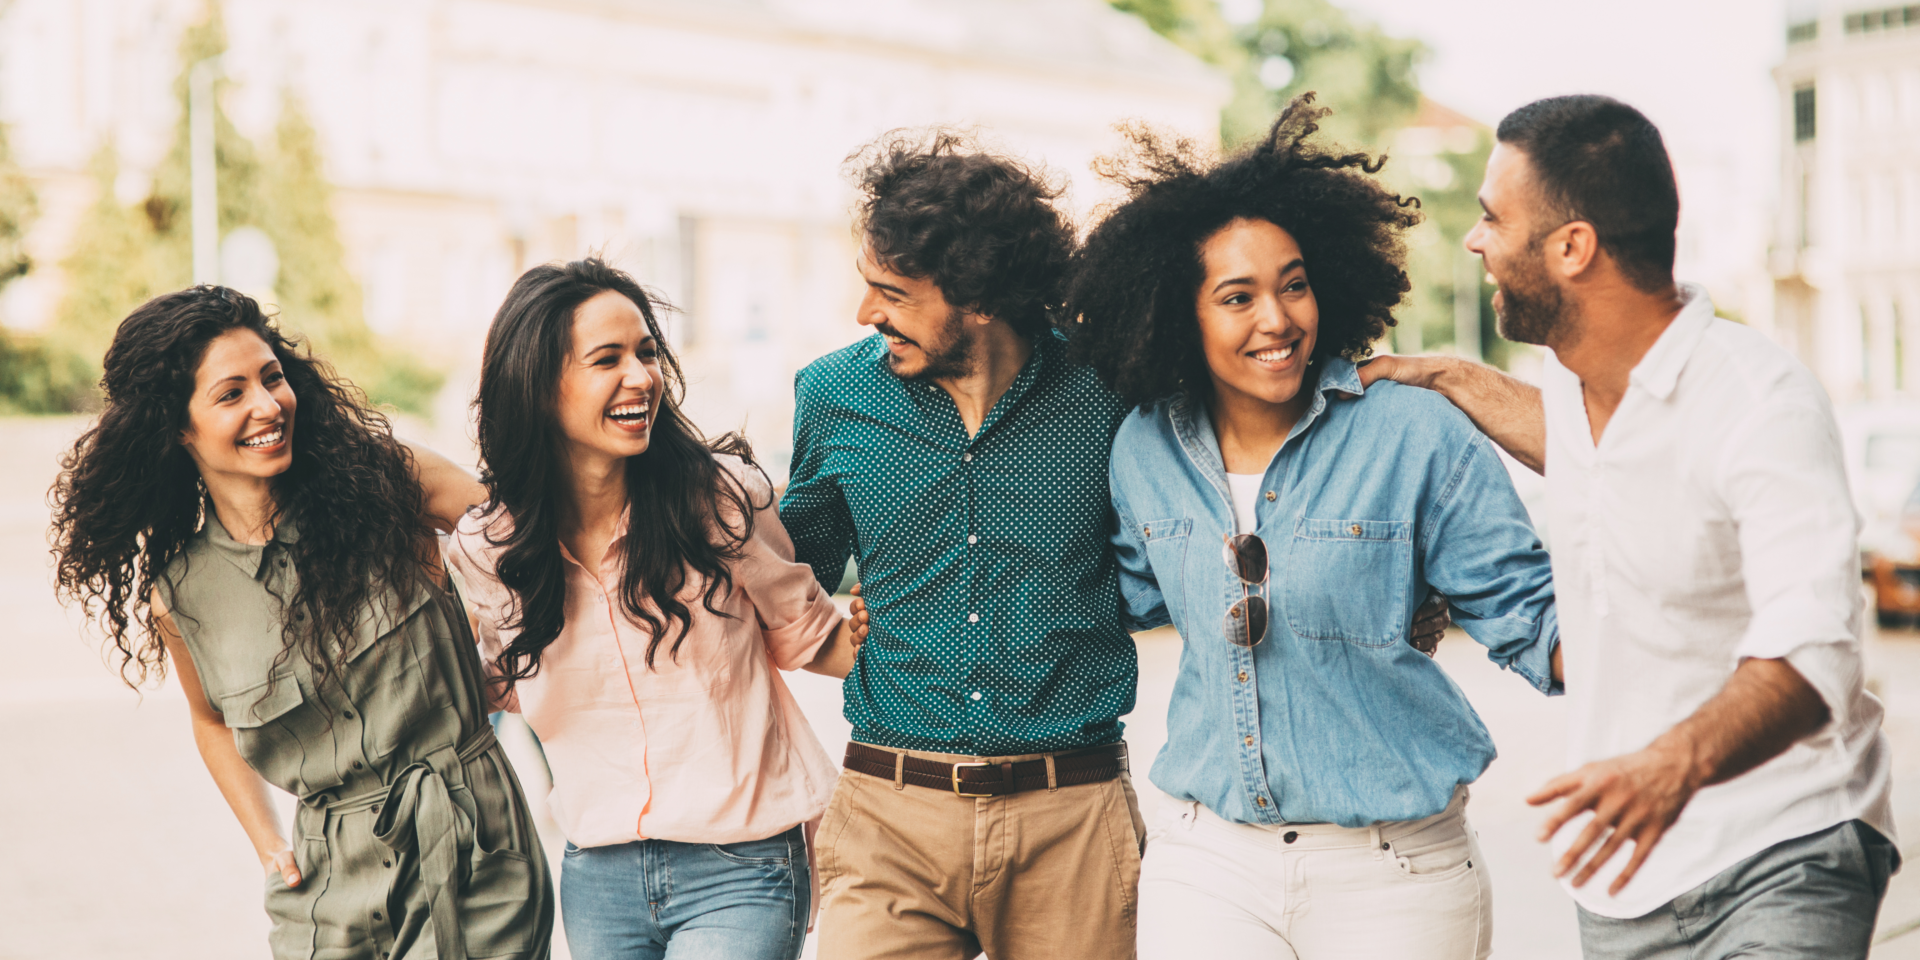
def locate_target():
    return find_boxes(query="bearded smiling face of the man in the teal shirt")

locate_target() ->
[854,248,977,380]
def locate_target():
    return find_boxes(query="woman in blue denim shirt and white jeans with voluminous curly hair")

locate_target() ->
[1066,94,1559,960]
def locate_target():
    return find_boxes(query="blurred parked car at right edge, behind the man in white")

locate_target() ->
[1837,401,1920,626]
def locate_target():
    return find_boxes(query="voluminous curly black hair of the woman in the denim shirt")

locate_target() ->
[1062,92,1421,405]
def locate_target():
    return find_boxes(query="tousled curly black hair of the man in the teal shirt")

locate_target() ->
[847,129,1073,338]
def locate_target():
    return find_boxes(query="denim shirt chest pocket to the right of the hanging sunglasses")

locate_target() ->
[1273,516,1413,647]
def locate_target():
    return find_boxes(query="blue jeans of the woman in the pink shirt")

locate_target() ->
[561,828,812,960]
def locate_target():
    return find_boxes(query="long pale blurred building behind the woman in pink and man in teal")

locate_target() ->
[0,0,1229,478]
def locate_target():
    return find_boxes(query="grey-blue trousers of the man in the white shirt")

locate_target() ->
[1580,820,1901,960]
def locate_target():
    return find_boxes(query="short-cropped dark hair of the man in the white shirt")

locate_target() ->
[1496,94,1680,292]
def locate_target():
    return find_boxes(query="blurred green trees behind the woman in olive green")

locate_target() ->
[0,4,445,415]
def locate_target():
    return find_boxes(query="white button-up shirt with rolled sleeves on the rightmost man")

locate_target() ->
[1542,284,1893,918]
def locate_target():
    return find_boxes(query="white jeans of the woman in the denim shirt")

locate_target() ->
[1140,787,1494,960]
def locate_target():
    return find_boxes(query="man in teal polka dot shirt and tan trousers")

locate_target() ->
[780,132,1144,960]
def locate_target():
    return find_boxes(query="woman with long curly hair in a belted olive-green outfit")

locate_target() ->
[54,286,553,960]
